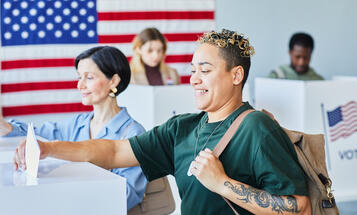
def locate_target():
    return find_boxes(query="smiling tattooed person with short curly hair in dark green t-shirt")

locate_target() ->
[15,29,311,215]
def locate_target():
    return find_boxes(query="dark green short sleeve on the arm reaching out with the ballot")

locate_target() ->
[129,119,176,181]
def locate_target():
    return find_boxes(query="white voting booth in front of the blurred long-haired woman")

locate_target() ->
[118,84,250,130]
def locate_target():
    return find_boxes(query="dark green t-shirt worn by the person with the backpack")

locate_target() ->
[129,103,308,215]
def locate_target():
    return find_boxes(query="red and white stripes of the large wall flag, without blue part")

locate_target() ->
[0,0,215,116]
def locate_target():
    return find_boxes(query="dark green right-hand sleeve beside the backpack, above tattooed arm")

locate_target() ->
[254,128,308,195]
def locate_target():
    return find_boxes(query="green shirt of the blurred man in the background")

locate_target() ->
[268,65,324,81]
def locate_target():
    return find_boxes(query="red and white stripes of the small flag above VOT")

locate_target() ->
[330,101,357,142]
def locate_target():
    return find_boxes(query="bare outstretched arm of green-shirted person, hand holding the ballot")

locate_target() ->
[14,139,139,169]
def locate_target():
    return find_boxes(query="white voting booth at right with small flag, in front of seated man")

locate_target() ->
[255,78,357,205]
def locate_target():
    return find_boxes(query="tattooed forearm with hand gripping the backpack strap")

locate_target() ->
[191,149,311,214]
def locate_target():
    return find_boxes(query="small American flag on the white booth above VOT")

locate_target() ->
[327,101,357,142]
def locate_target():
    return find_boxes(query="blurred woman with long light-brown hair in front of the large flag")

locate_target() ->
[130,28,180,86]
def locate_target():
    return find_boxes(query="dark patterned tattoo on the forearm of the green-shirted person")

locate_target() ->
[224,181,300,214]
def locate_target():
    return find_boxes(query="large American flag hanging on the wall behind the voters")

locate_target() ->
[0,0,215,117]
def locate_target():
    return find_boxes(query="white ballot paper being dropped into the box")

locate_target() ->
[25,123,40,178]
